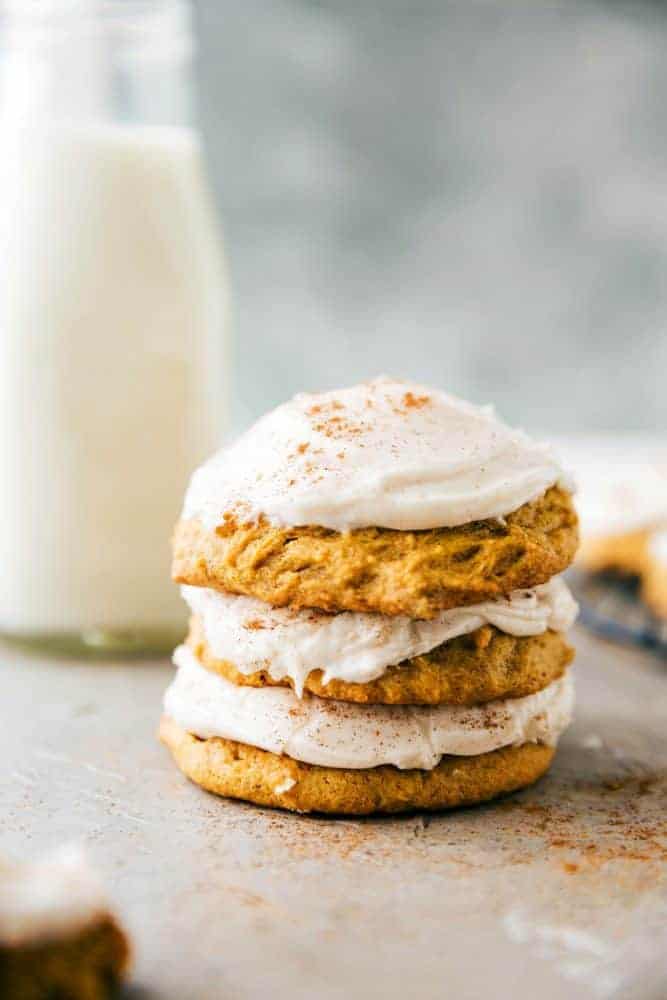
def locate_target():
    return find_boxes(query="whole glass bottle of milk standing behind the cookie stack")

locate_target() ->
[0,0,227,654]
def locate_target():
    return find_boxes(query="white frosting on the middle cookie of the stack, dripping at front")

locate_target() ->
[182,577,578,695]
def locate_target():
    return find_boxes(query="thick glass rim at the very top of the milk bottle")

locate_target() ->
[0,0,195,58]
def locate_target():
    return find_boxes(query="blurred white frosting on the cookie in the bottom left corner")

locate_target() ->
[0,846,108,946]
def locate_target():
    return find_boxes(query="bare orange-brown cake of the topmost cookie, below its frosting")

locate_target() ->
[173,486,578,618]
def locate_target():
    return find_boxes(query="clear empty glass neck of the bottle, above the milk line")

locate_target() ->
[0,0,194,125]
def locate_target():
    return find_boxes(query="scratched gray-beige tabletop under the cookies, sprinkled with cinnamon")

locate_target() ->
[0,630,667,1000]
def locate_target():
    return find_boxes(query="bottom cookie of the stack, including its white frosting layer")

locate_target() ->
[160,647,573,813]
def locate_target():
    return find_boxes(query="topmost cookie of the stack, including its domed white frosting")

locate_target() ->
[173,379,578,618]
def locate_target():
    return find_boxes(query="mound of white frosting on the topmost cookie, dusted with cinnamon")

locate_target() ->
[183,378,563,531]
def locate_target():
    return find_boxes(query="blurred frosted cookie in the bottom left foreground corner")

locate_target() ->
[0,848,129,1000]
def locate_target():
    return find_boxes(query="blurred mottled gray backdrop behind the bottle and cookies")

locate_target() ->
[196,0,667,431]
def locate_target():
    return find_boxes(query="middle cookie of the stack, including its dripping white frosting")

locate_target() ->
[183,578,578,705]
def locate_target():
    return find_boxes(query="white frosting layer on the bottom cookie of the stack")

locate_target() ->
[164,646,574,770]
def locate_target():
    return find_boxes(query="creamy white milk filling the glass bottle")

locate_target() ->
[0,119,226,635]
